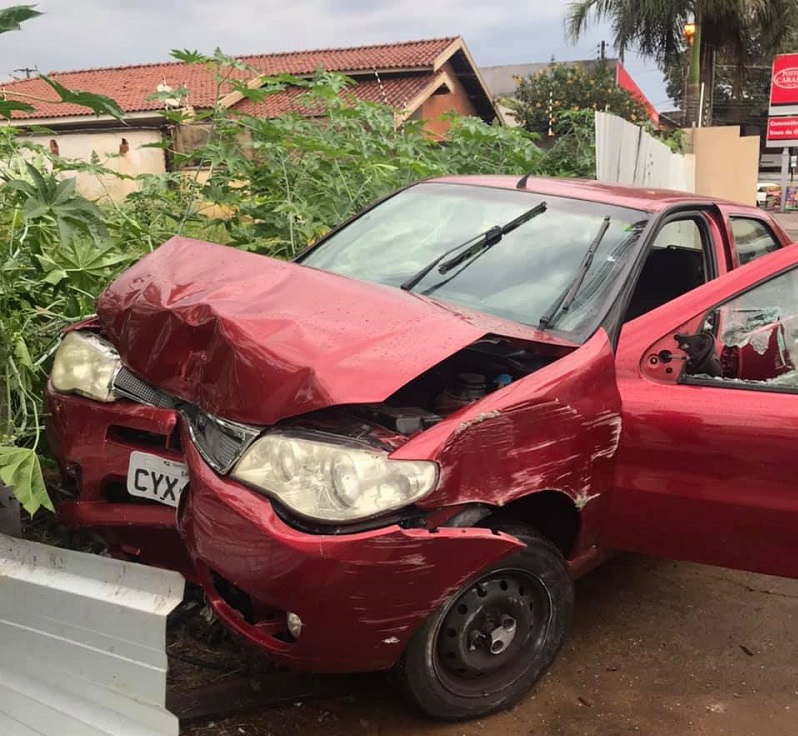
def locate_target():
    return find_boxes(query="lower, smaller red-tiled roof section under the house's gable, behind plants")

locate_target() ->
[233,73,435,117]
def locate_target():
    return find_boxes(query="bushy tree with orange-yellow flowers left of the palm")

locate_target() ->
[504,63,648,136]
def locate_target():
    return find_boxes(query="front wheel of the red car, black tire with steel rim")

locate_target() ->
[396,524,574,721]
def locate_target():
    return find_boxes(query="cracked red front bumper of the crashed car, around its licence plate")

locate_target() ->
[47,389,521,672]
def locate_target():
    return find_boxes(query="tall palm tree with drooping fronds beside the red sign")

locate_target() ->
[566,0,798,125]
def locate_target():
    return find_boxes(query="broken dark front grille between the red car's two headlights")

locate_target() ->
[113,368,261,474]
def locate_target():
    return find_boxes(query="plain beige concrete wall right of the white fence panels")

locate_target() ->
[685,126,759,205]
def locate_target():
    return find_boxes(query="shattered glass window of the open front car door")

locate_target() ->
[682,268,798,392]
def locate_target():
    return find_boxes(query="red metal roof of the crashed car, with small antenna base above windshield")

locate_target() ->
[429,176,755,212]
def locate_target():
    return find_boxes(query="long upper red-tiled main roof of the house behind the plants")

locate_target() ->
[2,37,457,119]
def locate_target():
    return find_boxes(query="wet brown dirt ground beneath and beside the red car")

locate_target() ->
[175,556,798,736]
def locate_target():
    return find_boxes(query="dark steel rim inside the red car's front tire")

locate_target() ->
[432,569,553,698]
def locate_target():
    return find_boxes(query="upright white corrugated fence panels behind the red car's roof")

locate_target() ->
[596,112,695,192]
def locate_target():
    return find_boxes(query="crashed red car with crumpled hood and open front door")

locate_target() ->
[47,177,798,719]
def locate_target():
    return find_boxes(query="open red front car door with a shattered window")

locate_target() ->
[599,246,798,577]
